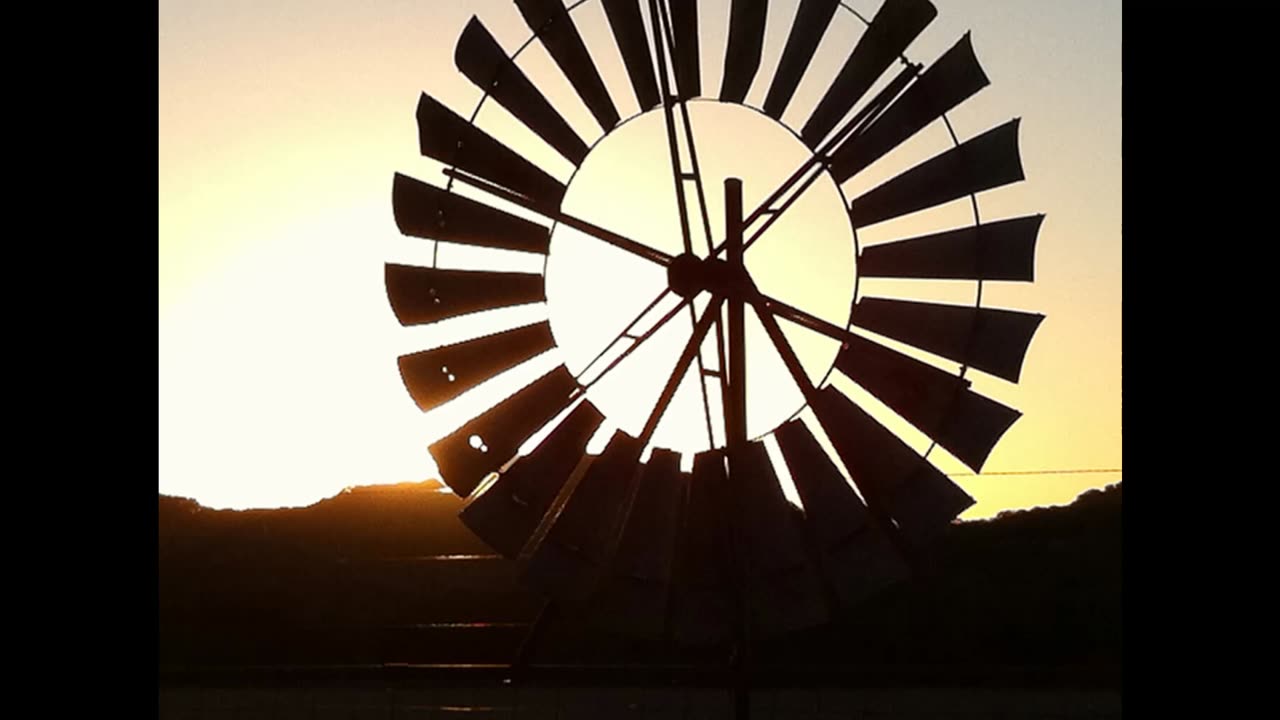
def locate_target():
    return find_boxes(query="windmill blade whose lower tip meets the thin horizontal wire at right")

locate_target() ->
[836,333,1021,471]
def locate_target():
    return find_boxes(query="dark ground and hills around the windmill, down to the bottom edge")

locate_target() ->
[159,484,1121,720]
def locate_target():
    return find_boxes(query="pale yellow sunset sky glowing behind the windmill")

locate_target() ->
[159,0,1123,518]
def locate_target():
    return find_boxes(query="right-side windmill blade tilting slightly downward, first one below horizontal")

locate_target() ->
[850,297,1044,383]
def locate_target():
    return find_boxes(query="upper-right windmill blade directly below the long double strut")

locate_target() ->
[831,32,991,183]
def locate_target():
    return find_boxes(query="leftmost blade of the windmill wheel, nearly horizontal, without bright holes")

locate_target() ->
[385,263,547,325]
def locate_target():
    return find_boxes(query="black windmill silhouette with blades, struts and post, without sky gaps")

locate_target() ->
[387,0,1043,702]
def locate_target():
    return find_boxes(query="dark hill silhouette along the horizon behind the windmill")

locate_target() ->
[159,483,1121,685]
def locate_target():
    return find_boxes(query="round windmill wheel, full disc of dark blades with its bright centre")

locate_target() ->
[387,0,1043,642]
